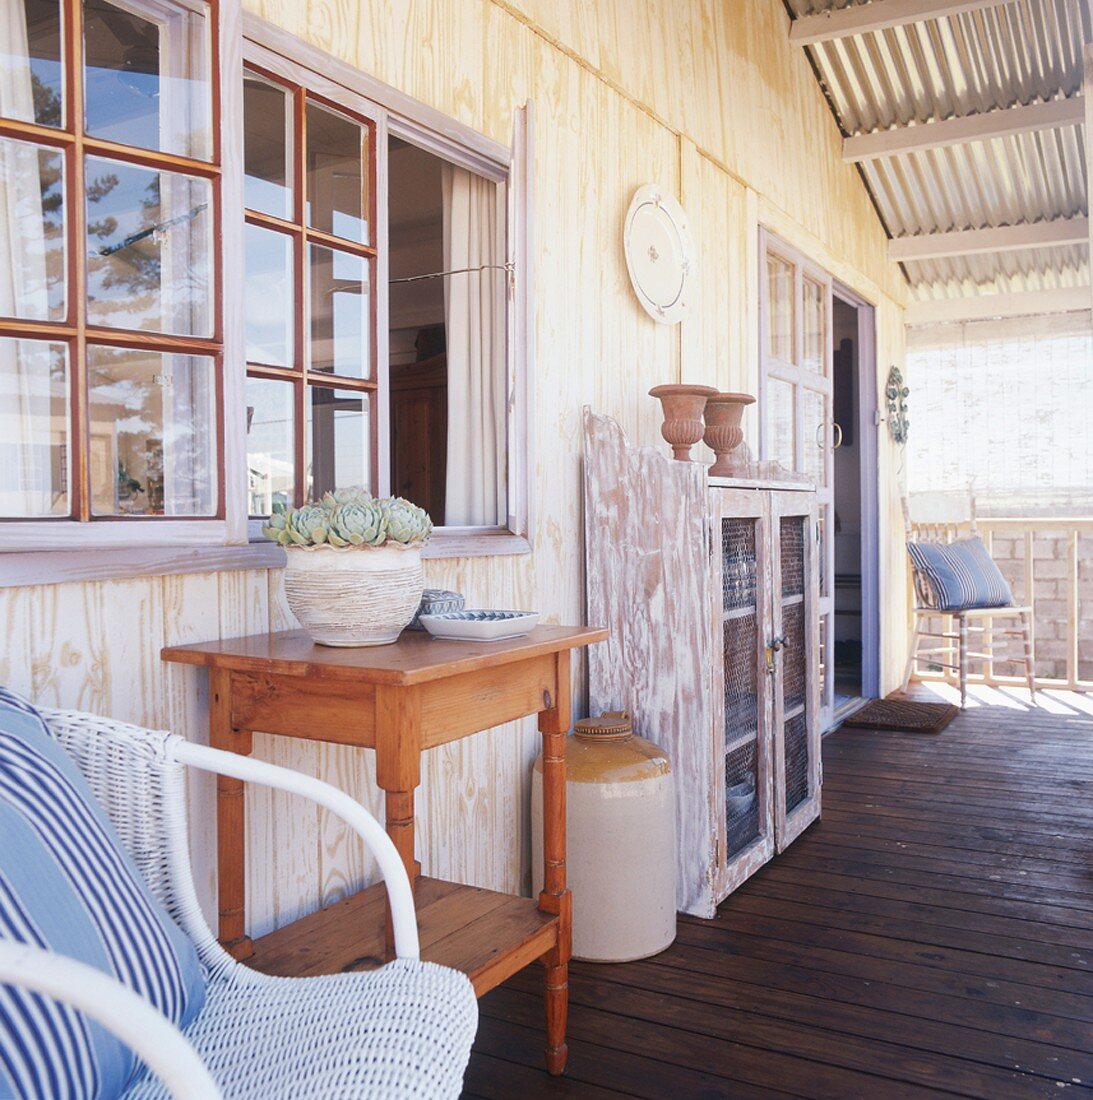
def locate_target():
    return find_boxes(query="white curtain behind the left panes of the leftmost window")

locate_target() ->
[0,2,53,516]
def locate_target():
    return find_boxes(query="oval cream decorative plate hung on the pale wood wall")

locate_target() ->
[622,184,695,325]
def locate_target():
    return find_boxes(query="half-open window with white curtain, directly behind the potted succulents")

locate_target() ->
[243,58,516,529]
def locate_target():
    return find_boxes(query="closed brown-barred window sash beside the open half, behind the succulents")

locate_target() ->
[243,69,377,516]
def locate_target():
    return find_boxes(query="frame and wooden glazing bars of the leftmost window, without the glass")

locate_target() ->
[0,0,245,554]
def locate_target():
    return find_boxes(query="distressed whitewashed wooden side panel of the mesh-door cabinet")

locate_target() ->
[585,409,716,913]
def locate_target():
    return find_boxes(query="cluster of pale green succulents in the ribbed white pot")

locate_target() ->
[262,485,432,549]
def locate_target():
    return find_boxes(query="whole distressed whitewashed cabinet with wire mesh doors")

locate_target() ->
[585,413,820,917]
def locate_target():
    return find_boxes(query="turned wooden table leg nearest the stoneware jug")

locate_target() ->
[539,651,573,1076]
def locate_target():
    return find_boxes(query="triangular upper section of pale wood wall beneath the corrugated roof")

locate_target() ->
[497,0,905,300]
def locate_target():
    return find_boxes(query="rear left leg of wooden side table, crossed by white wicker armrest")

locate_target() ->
[209,669,254,959]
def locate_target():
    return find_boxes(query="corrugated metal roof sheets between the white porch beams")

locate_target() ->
[788,0,1093,298]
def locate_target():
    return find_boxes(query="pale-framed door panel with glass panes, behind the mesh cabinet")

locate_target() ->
[759,232,836,729]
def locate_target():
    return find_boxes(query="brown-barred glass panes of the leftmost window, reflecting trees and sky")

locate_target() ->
[0,0,224,520]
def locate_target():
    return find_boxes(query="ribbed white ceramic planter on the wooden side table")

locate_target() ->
[285,546,424,646]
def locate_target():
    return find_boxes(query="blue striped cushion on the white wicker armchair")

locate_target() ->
[0,689,205,1100]
